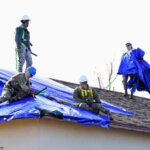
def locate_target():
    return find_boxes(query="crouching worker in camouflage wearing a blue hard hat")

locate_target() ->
[0,67,36,103]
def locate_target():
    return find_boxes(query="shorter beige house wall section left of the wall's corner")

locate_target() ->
[0,119,39,150]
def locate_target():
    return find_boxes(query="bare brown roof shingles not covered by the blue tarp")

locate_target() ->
[53,79,150,133]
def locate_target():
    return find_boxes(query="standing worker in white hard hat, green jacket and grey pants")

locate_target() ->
[15,15,32,72]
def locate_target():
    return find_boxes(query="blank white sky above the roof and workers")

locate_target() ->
[0,0,150,97]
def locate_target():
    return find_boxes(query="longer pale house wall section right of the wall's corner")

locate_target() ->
[39,119,150,150]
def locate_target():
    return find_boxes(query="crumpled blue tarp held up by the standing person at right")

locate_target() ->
[118,48,150,93]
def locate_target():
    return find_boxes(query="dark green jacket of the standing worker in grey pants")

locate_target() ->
[15,25,31,50]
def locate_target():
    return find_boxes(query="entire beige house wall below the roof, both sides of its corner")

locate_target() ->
[0,119,150,150]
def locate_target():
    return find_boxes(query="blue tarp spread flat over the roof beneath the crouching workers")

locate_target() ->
[0,69,133,128]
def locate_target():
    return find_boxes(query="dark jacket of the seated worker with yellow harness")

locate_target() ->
[73,86,100,103]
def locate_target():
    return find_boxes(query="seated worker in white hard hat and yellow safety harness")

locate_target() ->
[73,75,112,120]
